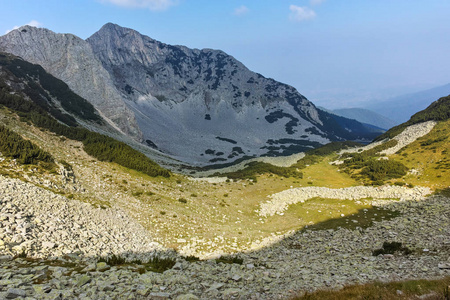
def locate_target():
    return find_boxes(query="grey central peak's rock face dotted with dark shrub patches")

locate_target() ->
[87,24,329,163]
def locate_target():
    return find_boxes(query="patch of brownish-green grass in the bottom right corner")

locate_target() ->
[292,277,450,300]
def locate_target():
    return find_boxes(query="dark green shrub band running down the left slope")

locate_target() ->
[0,56,170,177]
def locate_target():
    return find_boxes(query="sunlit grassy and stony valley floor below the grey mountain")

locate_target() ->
[0,92,450,299]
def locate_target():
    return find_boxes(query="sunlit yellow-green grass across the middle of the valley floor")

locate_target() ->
[2,106,440,252]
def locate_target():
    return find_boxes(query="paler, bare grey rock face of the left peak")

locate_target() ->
[0,26,141,138]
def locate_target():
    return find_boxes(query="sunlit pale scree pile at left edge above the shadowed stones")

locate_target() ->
[0,176,162,257]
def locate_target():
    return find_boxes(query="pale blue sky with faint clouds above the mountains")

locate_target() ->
[0,0,450,108]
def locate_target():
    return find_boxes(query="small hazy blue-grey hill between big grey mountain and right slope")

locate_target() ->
[332,108,397,129]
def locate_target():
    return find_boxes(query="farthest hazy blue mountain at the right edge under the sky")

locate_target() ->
[365,84,450,124]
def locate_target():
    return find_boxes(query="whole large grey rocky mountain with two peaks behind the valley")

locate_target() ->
[0,23,376,165]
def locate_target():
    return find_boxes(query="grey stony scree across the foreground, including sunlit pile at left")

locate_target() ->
[0,177,450,299]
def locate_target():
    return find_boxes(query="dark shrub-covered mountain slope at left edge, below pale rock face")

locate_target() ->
[0,52,170,177]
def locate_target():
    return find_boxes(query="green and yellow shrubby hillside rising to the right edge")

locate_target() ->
[222,96,450,185]
